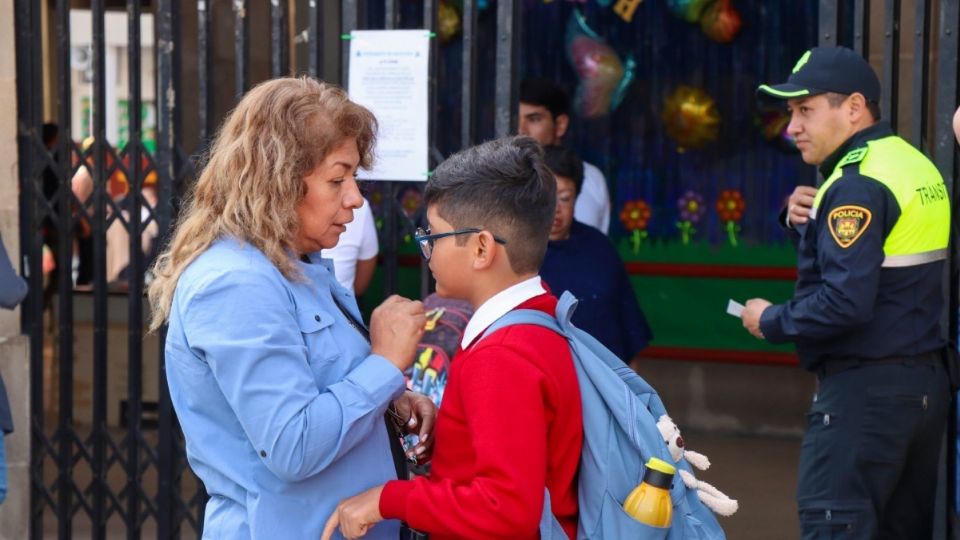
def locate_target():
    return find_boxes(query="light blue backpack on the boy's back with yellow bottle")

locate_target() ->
[484,292,725,540]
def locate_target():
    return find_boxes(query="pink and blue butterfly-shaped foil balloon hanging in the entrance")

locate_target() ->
[566,10,636,118]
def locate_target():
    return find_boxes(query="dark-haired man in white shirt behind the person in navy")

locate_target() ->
[517,79,610,234]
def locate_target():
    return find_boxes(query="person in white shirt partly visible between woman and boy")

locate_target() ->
[320,198,380,296]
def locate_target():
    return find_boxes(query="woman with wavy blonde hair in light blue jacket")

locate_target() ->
[149,78,436,538]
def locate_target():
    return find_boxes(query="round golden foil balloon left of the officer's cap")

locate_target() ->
[660,85,720,152]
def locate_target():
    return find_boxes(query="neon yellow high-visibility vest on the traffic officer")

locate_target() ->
[811,135,950,267]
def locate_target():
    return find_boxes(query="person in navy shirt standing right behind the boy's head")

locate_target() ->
[540,146,653,364]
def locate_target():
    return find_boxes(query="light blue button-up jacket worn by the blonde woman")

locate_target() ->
[166,238,404,540]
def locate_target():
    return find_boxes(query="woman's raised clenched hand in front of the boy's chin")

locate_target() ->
[370,295,427,371]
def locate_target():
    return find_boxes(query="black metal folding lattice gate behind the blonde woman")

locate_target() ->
[14,0,519,538]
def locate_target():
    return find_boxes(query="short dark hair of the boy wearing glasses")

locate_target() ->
[424,136,557,274]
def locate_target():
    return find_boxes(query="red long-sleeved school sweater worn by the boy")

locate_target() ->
[380,294,583,540]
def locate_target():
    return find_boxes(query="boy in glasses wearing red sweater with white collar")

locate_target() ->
[323,137,583,540]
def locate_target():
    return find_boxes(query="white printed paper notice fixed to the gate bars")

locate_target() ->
[348,30,430,182]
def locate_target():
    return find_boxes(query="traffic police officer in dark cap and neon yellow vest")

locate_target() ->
[742,47,950,539]
